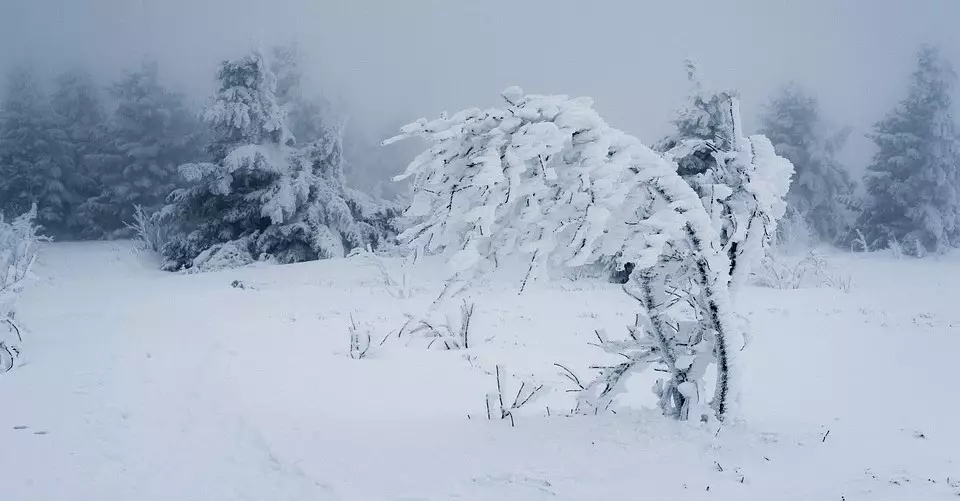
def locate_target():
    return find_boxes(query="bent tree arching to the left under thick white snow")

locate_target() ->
[385,88,789,420]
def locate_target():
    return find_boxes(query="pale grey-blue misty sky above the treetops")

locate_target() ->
[0,0,960,180]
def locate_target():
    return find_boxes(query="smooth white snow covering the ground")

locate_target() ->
[0,242,960,501]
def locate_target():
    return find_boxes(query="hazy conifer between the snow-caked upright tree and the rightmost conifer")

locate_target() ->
[761,83,854,243]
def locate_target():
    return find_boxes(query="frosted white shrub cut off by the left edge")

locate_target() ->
[0,203,42,372]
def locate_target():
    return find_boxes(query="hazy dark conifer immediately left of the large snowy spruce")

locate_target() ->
[80,62,203,236]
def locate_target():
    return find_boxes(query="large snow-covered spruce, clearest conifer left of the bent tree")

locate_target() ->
[156,53,389,270]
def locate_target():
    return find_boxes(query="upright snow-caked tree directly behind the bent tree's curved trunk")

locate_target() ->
[655,61,793,293]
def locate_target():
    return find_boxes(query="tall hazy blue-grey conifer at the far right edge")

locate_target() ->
[856,46,960,254]
